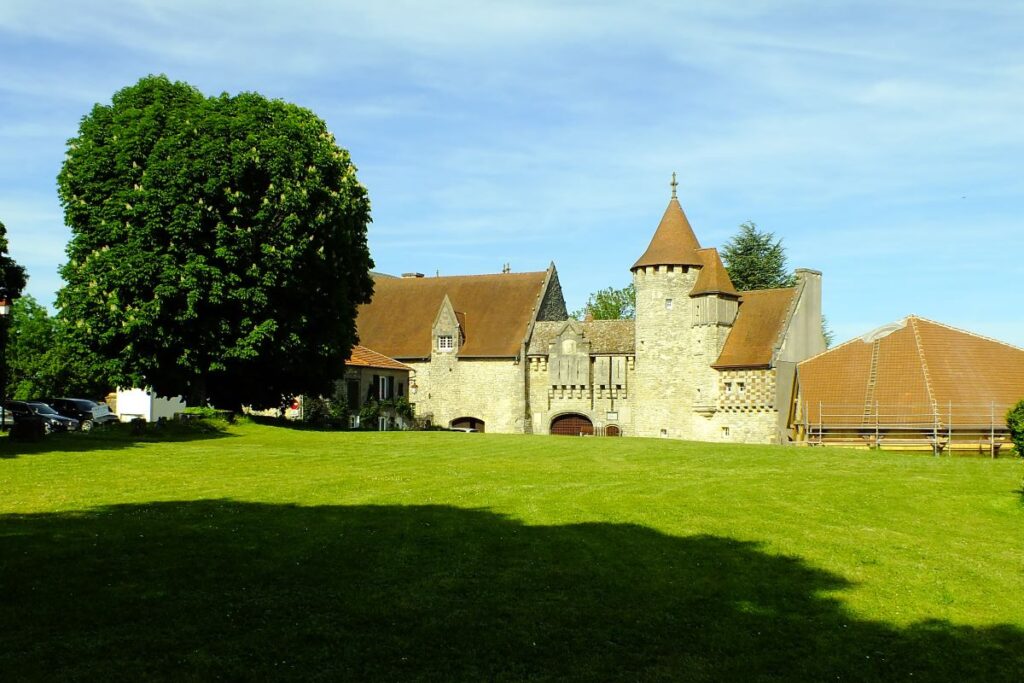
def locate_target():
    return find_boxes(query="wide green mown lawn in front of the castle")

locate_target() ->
[0,424,1024,681]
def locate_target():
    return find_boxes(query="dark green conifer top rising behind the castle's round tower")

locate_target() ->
[722,221,796,291]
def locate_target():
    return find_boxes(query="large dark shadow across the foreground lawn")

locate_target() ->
[0,501,1024,681]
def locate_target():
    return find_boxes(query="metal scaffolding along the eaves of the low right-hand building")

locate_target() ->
[801,401,1012,458]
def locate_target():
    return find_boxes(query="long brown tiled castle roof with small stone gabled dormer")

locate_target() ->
[356,271,548,358]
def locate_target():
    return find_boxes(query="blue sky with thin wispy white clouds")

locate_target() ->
[0,0,1024,346]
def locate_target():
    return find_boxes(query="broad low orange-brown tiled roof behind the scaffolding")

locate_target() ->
[799,315,1024,428]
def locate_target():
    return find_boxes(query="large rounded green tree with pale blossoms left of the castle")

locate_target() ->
[57,76,373,407]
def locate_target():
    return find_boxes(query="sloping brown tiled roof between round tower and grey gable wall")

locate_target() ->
[712,287,797,369]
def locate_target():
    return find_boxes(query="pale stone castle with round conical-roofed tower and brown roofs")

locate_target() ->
[358,189,825,443]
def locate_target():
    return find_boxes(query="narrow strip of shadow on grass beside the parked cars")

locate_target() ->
[0,421,232,460]
